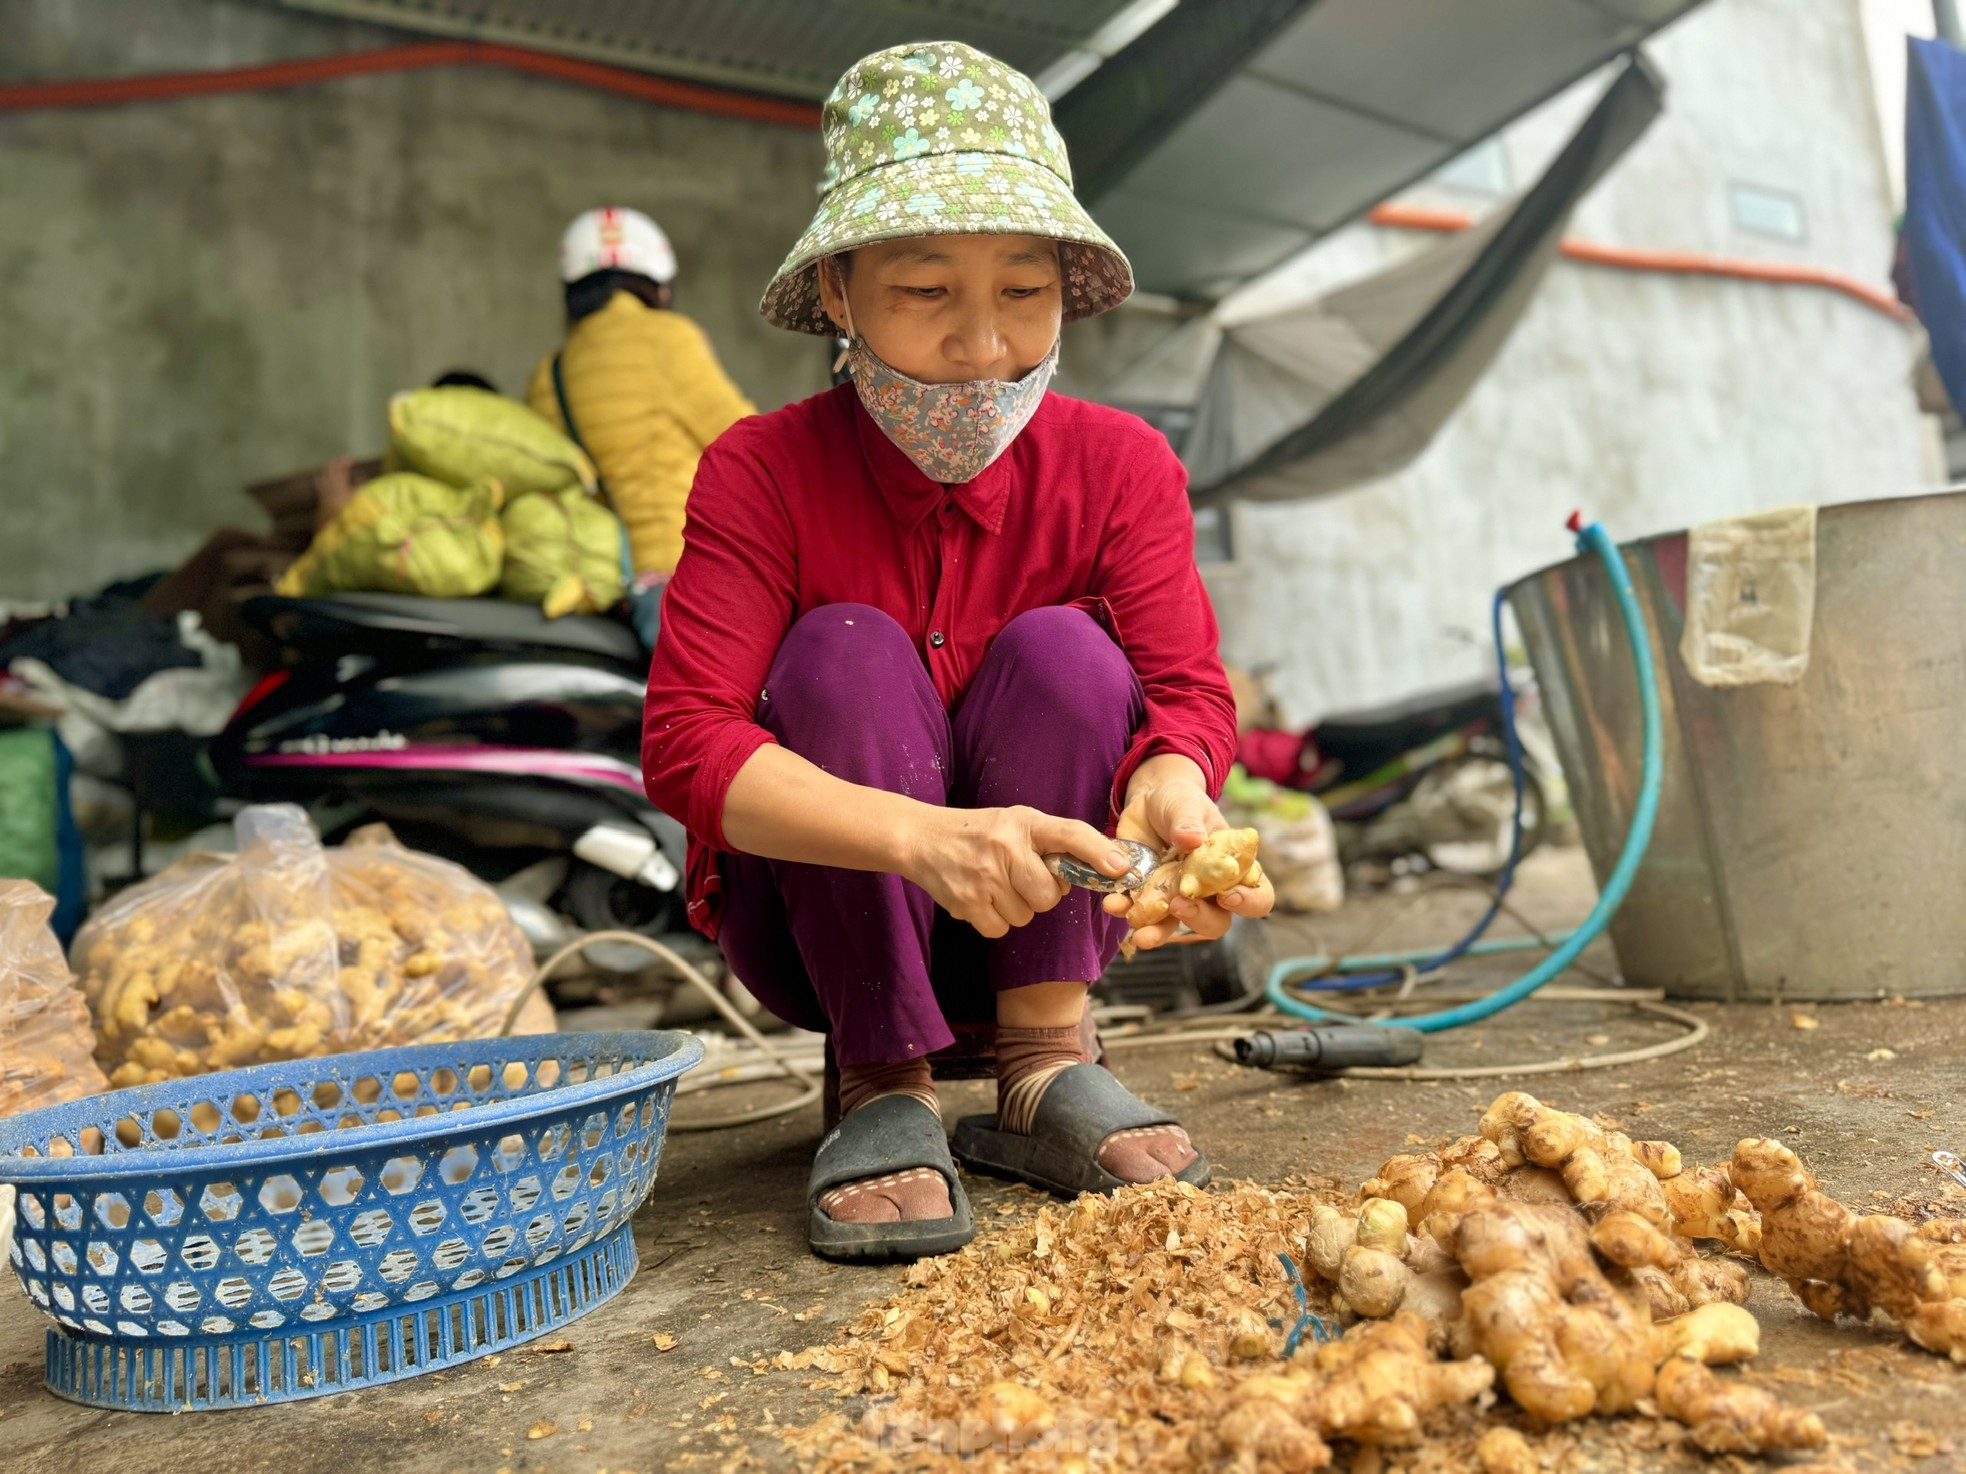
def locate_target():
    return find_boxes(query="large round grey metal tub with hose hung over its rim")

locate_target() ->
[1508,493,1966,1000]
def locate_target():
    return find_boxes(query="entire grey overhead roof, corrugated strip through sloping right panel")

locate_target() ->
[263,0,1699,301]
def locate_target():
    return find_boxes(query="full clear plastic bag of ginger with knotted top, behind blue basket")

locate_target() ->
[75,804,533,1087]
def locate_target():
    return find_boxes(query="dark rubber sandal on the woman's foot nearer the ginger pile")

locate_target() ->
[955,1065,1209,1197]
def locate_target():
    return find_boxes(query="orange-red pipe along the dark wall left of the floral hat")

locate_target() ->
[0,41,820,128]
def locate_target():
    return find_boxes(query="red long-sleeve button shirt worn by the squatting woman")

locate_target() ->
[641,385,1235,935]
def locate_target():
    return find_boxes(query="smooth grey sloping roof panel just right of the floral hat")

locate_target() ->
[1062,0,1699,301]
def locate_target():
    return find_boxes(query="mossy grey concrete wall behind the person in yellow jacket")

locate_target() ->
[0,0,826,599]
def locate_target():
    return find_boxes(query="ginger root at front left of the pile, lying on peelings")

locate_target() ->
[1193,1315,1494,1470]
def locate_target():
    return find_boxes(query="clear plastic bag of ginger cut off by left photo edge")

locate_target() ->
[0,880,108,1116]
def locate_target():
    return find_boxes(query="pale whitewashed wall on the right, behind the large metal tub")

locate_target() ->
[1148,0,1938,721]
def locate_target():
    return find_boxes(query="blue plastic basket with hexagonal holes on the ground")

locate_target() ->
[0,1032,704,1411]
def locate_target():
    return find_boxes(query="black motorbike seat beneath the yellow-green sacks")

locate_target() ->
[240,594,649,666]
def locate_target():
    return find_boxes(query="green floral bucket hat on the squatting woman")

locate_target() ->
[759,41,1132,334]
